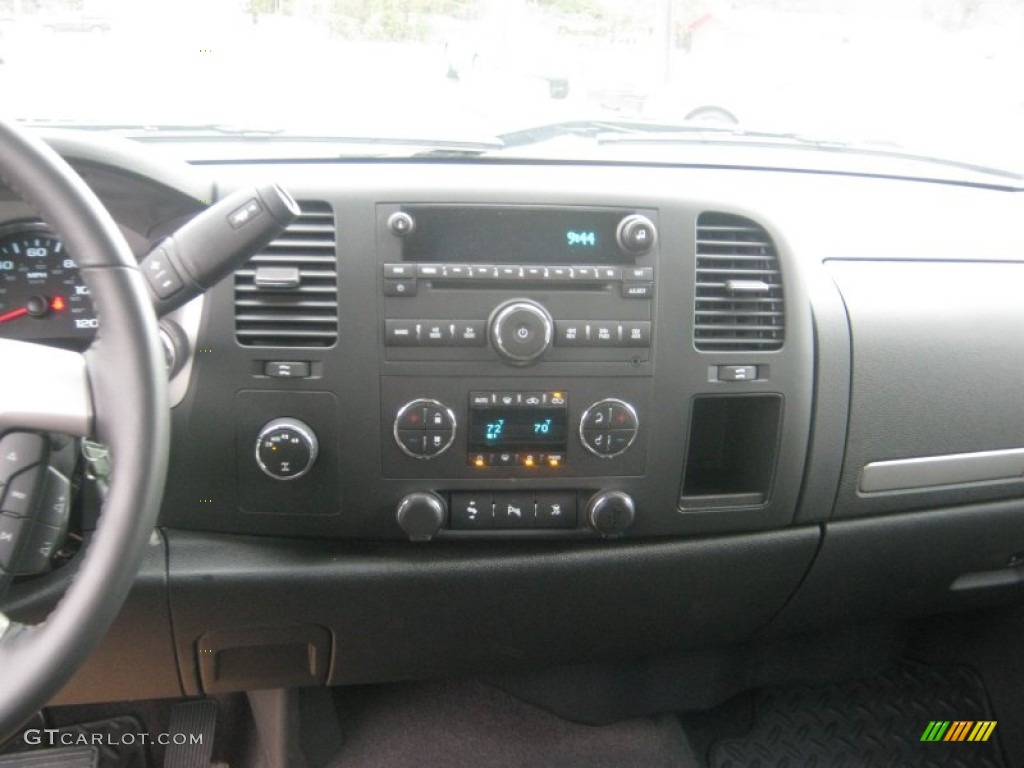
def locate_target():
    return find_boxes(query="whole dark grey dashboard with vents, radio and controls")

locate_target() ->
[0,131,1024,700]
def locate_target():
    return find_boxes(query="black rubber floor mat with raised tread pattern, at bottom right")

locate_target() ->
[708,663,1008,768]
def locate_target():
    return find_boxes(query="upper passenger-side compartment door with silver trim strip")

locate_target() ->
[827,261,1024,518]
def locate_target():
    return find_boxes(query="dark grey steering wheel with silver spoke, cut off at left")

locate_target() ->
[0,121,170,741]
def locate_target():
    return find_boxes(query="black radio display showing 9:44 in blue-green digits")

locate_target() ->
[401,206,634,264]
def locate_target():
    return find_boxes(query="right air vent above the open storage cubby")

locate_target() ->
[693,213,785,351]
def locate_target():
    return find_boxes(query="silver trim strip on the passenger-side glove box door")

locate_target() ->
[859,449,1024,494]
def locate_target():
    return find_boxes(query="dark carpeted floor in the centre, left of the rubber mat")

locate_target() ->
[331,682,696,768]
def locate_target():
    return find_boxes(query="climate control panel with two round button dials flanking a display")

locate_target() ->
[382,385,648,479]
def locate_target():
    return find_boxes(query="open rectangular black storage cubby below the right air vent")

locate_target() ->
[679,394,782,510]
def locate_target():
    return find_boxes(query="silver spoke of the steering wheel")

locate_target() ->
[0,339,93,435]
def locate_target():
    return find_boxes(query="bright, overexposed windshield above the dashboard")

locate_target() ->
[0,0,1024,173]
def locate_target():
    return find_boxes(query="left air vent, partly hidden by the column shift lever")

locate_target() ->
[234,201,338,347]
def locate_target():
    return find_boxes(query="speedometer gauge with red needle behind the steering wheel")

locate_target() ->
[0,222,97,349]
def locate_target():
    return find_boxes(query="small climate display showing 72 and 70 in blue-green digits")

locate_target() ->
[469,406,568,452]
